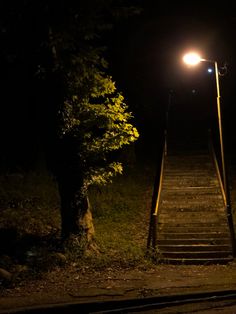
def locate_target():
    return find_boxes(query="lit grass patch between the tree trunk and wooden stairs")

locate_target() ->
[88,165,154,264]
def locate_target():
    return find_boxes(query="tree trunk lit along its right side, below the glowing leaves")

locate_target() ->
[49,132,94,253]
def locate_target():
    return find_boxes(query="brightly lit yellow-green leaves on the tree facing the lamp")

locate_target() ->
[60,57,139,189]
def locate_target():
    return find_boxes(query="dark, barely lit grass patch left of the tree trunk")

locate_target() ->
[0,172,60,236]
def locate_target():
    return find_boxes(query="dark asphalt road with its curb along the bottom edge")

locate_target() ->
[0,290,236,314]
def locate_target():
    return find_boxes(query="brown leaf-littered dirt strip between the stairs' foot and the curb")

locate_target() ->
[0,262,236,313]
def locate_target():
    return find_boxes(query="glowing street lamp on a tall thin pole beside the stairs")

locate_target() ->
[183,52,230,207]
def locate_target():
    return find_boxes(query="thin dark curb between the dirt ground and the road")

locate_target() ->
[0,290,236,314]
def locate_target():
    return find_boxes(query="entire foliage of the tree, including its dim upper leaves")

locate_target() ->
[50,1,139,189]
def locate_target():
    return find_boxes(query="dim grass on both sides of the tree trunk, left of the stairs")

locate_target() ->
[0,157,159,281]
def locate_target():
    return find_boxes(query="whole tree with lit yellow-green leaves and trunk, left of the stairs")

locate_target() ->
[42,1,138,250]
